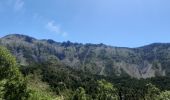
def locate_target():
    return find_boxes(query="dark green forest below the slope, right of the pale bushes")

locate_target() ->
[21,59,170,100]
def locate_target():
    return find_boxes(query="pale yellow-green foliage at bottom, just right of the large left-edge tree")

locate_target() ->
[27,72,57,100]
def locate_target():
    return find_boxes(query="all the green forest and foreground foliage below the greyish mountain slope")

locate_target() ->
[0,47,170,100]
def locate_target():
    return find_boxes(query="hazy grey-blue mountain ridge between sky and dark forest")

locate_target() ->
[0,34,170,78]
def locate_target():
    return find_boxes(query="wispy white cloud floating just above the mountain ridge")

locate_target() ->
[46,21,68,37]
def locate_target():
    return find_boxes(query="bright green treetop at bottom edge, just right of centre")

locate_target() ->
[97,80,118,100]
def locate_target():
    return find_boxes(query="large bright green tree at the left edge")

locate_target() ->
[0,46,29,100]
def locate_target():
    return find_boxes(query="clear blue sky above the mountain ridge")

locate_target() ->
[0,0,170,47]
